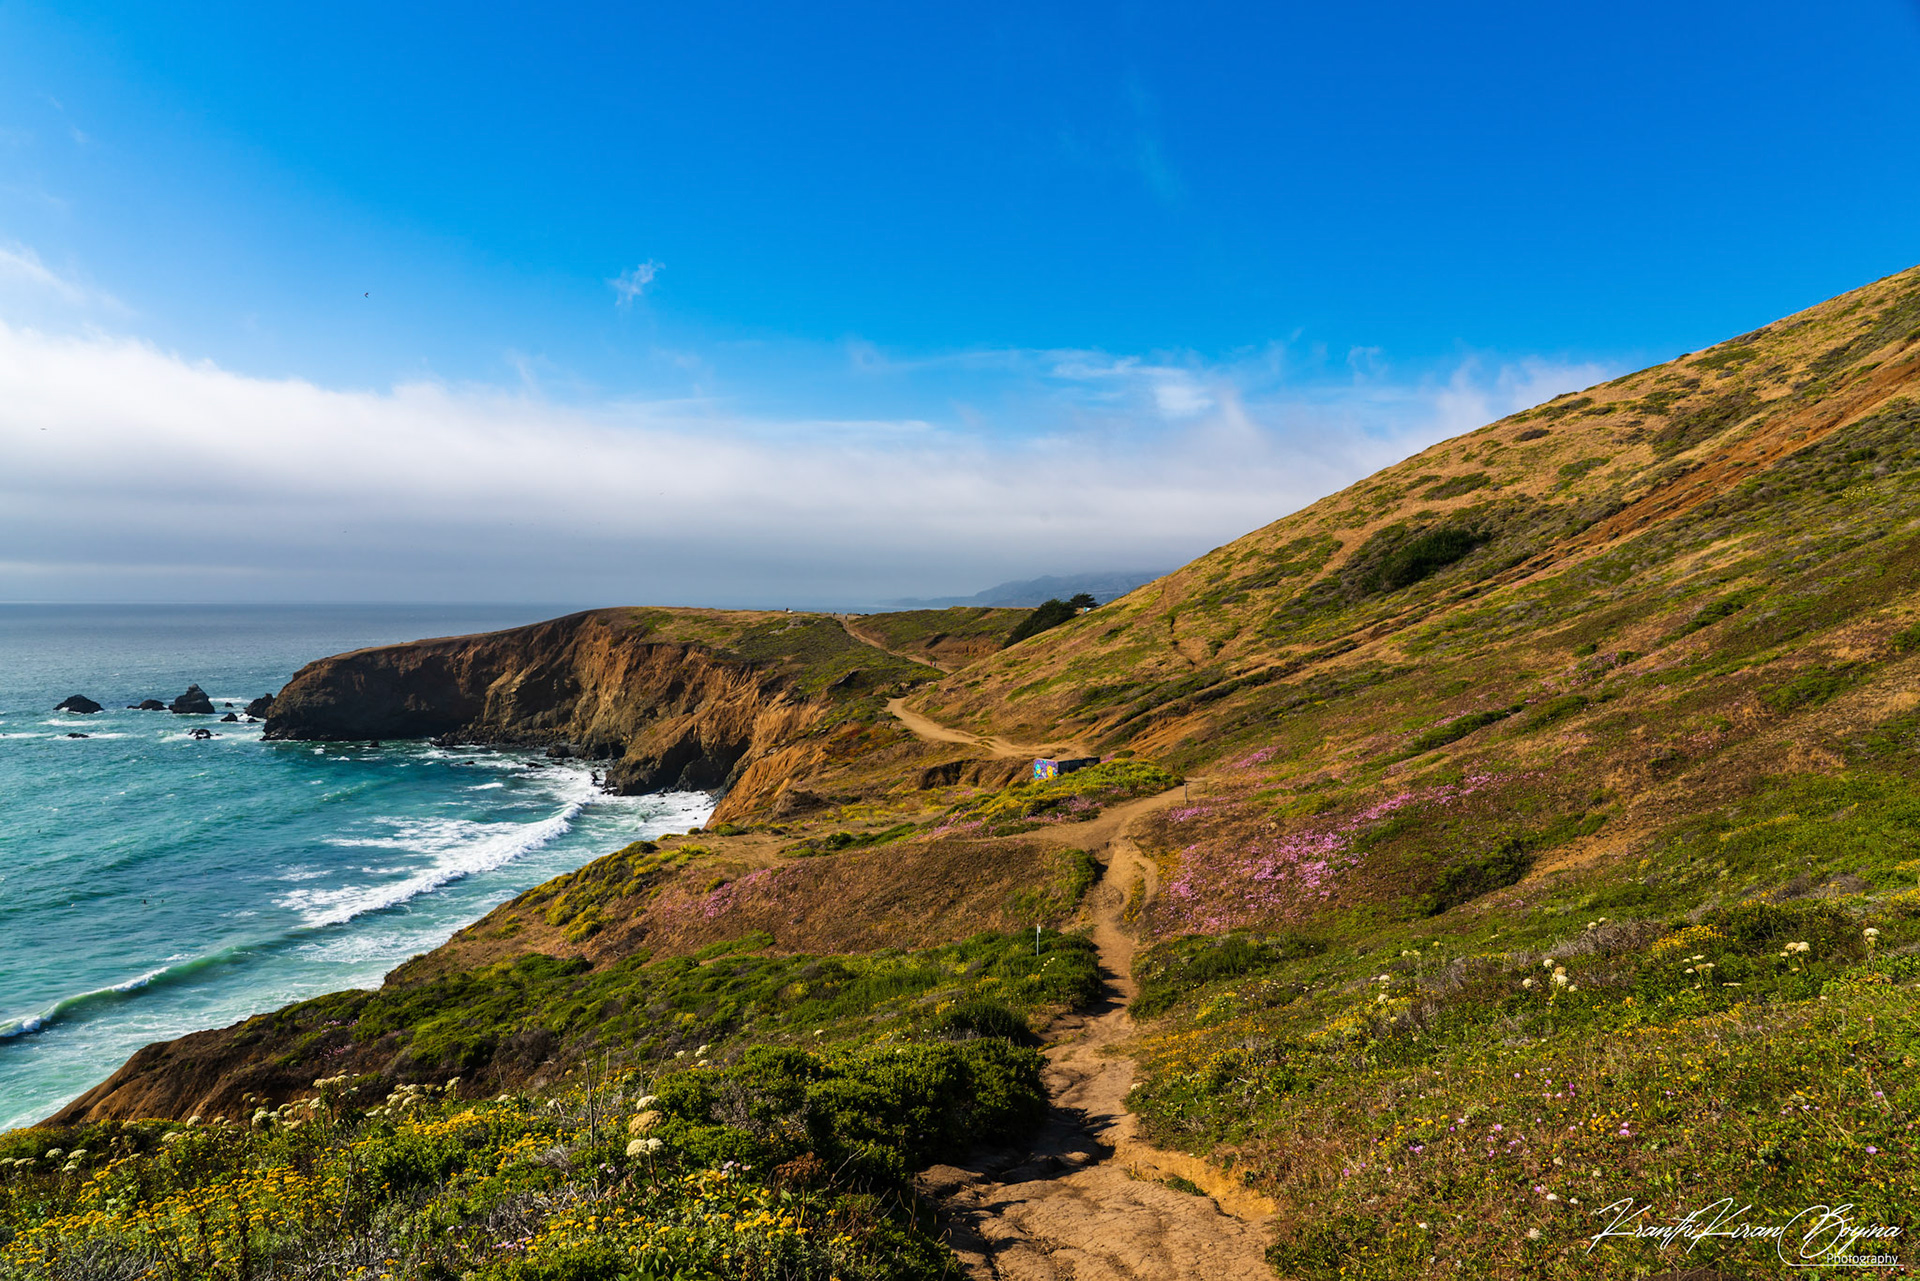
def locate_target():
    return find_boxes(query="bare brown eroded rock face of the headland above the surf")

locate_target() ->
[265,611,826,812]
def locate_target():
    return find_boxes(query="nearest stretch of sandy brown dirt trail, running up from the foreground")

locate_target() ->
[918,789,1273,1281]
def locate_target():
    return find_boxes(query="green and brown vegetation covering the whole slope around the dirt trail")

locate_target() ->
[11,269,1920,1281]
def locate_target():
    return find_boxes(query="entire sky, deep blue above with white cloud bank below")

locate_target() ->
[0,0,1920,605]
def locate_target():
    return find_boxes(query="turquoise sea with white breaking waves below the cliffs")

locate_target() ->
[0,605,710,1129]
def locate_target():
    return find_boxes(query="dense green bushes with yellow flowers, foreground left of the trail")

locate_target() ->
[0,1039,1021,1281]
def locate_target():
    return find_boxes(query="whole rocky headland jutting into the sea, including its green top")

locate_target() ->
[265,609,941,820]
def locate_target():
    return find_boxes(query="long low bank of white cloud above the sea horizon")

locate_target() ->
[0,314,1609,605]
